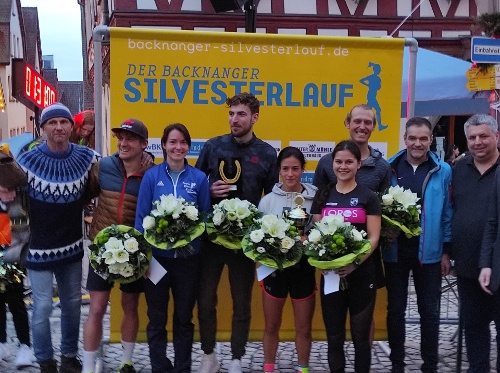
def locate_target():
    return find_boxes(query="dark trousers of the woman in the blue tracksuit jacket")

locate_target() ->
[144,255,200,373]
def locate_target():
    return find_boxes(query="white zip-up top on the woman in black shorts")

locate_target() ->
[259,183,318,217]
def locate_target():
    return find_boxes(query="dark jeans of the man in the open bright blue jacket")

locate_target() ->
[385,257,441,373]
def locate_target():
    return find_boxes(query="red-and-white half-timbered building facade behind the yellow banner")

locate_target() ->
[79,0,494,152]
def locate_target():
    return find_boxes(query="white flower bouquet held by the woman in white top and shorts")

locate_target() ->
[241,214,304,270]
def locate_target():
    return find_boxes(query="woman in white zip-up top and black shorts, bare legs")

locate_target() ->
[259,146,317,373]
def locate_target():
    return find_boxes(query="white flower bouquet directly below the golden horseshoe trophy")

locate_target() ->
[206,198,261,250]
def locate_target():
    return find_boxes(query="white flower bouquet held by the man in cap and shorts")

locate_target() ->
[89,225,152,283]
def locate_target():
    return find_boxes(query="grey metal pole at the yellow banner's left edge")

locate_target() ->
[92,25,109,154]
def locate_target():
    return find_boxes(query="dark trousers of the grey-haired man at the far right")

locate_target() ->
[457,276,500,373]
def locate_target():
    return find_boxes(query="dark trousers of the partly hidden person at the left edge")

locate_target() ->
[0,282,31,346]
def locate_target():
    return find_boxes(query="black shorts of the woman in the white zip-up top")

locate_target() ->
[260,257,316,300]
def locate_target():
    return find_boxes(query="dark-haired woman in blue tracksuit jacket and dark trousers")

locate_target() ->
[135,123,210,373]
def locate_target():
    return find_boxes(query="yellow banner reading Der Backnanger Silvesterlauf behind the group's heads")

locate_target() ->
[111,28,404,170]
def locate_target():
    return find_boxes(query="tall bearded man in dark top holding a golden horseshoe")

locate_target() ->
[196,93,278,373]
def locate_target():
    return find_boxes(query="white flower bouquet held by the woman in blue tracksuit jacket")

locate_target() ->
[142,194,205,251]
